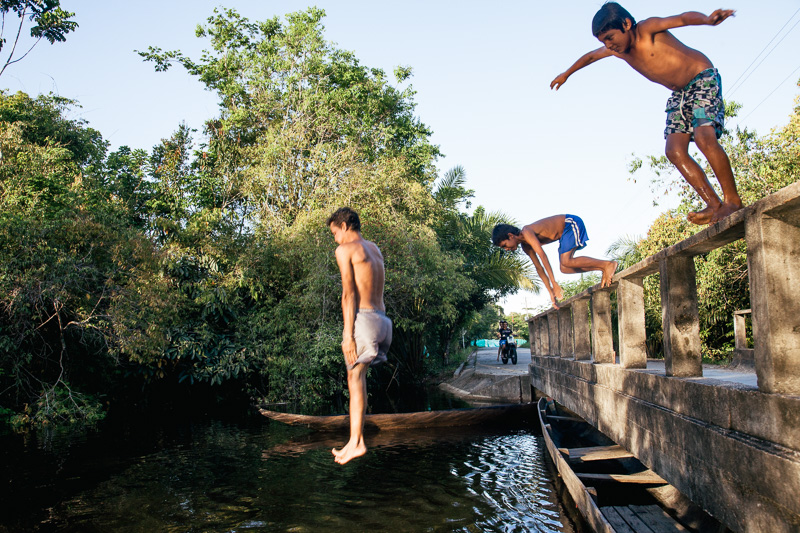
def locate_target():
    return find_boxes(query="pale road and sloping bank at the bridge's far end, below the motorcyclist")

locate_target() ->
[440,348,531,403]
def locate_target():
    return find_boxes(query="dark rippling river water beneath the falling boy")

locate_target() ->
[0,392,582,533]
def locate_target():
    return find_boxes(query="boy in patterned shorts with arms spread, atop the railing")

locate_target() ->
[550,2,742,224]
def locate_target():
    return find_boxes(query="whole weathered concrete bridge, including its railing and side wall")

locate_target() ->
[528,183,800,533]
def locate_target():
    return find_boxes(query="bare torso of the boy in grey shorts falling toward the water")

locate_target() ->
[337,239,386,311]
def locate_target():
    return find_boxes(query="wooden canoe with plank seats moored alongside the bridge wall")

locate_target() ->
[537,397,727,533]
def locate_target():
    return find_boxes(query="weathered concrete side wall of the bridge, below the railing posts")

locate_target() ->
[530,356,800,533]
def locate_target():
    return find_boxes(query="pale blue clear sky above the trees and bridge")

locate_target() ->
[0,0,800,311]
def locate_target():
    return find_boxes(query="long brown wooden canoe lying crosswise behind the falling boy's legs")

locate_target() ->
[259,402,536,431]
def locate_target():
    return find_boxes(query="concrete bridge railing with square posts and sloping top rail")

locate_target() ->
[528,182,800,395]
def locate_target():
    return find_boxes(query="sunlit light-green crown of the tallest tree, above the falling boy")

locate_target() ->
[140,8,439,231]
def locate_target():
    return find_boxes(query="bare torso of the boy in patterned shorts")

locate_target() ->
[611,20,714,91]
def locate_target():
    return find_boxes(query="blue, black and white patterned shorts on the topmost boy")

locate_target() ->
[664,68,725,139]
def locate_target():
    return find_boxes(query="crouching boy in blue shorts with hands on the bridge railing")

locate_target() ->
[492,215,617,309]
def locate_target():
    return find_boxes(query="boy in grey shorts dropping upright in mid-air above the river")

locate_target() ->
[328,207,392,464]
